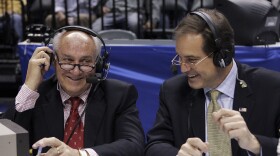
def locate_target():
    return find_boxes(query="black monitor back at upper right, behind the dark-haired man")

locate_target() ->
[214,0,280,46]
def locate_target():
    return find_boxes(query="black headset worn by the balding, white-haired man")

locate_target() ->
[45,26,110,80]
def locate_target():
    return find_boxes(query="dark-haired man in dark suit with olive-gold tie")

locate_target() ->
[145,9,280,156]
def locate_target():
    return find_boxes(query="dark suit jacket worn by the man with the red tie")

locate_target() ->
[2,78,144,156]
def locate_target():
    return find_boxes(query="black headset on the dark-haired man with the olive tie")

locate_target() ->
[190,11,233,68]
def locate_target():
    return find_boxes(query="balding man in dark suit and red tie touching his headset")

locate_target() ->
[2,27,144,156]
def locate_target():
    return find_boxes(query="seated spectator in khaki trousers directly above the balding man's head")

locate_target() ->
[45,0,98,28]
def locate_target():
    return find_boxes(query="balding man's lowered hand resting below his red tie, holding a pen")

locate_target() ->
[32,137,79,156]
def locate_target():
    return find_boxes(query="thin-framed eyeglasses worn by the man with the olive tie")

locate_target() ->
[171,52,213,68]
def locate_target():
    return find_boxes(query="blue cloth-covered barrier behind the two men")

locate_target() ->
[12,40,280,132]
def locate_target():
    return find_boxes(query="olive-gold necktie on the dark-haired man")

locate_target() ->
[207,90,232,156]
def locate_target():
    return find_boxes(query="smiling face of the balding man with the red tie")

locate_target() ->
[55,31,97,96]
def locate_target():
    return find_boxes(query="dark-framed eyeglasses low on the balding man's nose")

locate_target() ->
[55,54,96,73]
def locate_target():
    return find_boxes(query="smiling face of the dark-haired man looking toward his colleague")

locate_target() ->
[176,33,232,89]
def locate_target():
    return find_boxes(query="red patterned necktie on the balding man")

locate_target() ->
[64,97,84,149]
